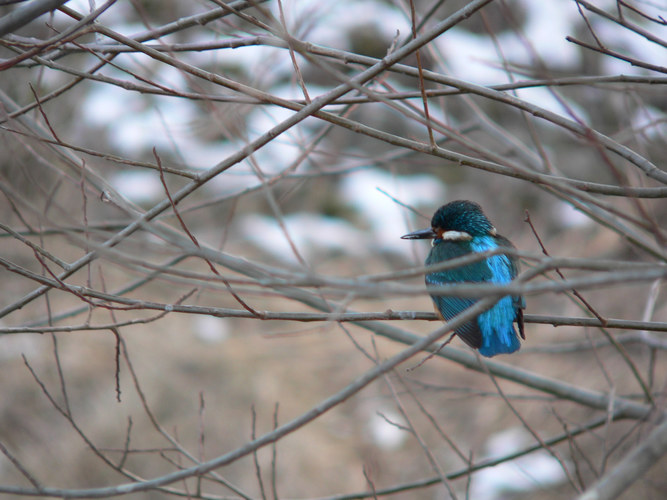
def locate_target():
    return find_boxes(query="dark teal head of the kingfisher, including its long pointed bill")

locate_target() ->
[401,200,496,241]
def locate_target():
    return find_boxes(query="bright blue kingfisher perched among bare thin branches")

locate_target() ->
[401,200,526,357]
